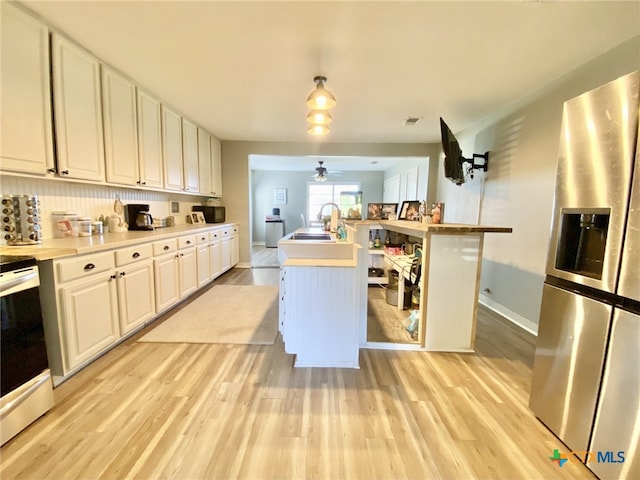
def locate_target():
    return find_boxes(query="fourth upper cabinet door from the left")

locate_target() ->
[137,89,163,188]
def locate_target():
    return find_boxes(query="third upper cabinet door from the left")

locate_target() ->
[102,65,139,185]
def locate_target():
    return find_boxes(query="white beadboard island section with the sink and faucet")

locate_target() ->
[278,227,366,368]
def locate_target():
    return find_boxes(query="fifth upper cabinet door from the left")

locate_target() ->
[162,105,182,190]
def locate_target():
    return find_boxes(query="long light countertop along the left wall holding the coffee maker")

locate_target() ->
[0,222,237,261]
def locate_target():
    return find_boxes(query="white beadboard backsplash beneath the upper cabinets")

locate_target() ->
[0,175,218,245]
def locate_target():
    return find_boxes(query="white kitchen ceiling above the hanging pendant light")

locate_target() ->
[21,0,640,152]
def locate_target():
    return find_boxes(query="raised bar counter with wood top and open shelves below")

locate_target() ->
[352,220,512,352]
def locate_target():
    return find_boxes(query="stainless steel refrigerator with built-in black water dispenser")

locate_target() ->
[529,72,640,479]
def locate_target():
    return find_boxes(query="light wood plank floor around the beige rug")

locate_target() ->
[0,269,594,479]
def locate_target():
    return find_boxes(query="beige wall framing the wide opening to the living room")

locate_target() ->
[222,141,432,266]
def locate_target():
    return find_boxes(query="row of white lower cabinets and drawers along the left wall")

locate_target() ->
[39,226,238,385]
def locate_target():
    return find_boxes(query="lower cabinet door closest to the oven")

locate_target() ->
[60,271,120,369]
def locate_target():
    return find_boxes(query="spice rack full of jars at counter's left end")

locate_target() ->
[2,195,42,245]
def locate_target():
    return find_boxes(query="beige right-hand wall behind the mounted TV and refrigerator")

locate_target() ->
[437,37,640,330]
